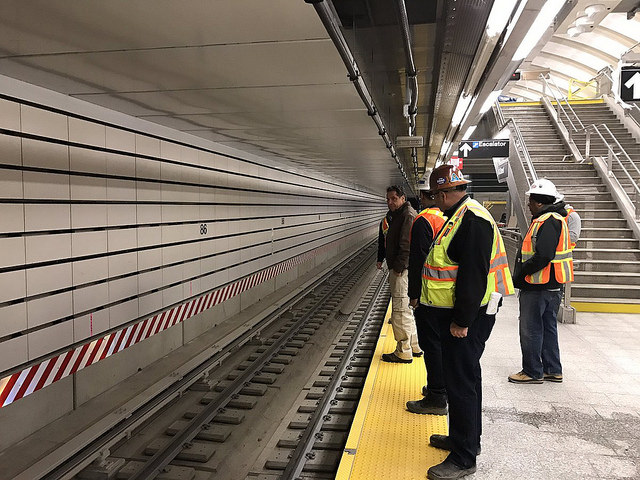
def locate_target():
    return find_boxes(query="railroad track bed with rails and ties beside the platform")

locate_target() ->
[61,246,388,479]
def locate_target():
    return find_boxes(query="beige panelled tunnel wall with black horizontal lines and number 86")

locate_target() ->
[0,80,386,447]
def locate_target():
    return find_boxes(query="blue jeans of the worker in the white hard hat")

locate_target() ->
[520,290,562,378]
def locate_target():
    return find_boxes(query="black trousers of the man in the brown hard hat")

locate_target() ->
[427,307,496,468]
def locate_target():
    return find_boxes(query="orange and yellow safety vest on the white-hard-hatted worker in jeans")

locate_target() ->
[521,212,573,285]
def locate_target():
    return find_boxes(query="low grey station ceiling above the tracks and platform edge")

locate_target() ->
[0,0,637,193]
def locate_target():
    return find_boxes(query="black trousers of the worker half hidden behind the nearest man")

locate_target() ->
[413,304,446,395]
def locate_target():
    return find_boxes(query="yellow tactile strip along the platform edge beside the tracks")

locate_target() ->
[336,302,447,480]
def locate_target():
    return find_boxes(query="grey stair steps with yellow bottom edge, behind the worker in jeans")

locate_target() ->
[501,103,640,311]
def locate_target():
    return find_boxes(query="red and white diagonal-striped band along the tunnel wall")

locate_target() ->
[0,239,344,408]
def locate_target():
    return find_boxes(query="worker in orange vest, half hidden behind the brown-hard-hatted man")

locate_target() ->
[407,169,447,415]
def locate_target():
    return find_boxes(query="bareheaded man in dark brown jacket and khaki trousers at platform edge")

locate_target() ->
[382,185,422,363]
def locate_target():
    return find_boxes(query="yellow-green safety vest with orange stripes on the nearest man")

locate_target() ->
[420,199,514,308]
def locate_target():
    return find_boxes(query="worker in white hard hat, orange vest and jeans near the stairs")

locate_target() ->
[508,178,573,383]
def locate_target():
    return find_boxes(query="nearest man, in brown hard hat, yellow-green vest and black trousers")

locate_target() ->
[420,165,513,479]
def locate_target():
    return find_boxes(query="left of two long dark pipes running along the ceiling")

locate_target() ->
[304,0,410,190]
